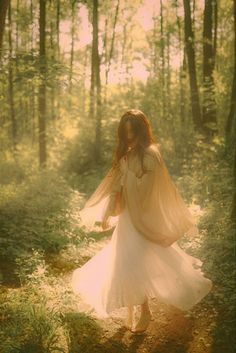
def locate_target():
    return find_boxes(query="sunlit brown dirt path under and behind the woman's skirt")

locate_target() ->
[48,231,218,353]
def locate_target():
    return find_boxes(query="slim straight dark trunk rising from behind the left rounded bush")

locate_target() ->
[38,0,47,167]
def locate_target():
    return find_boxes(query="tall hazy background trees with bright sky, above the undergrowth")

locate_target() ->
[0,0,235,165]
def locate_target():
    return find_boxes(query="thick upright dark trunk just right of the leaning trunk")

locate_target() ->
[202,0,217,135]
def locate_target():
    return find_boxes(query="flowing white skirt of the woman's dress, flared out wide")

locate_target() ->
[71,198,213,317]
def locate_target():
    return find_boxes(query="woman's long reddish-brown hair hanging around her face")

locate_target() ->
[112,109,156,171]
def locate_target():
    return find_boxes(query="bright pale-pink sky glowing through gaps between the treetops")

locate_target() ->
[60,0,197,86]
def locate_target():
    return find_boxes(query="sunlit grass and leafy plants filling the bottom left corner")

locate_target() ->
[0,246,101,353]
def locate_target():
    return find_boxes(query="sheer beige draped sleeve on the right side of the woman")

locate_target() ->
[124,146,198,247]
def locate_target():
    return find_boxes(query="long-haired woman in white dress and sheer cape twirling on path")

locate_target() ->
[72,109,212,332]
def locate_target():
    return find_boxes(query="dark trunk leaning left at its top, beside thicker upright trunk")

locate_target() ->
[184,0,202,129]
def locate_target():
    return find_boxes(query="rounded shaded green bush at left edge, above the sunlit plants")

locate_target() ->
[0,168,70,256]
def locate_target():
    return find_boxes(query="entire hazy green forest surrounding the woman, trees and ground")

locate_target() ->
[0,0,236,353]
